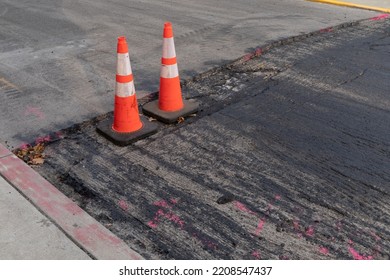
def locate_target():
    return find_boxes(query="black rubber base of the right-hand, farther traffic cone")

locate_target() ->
[142,100,199,123]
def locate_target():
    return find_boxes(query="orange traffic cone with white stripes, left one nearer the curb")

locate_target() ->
[97,37,157,146]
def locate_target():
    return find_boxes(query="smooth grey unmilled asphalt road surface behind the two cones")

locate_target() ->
[0,0,377,147]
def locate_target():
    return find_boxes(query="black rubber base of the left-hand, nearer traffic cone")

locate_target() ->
[96,116,158,146]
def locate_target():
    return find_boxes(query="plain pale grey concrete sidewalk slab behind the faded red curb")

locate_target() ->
[0,174,91,260]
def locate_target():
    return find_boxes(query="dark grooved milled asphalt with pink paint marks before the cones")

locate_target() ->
[37,18,390,259]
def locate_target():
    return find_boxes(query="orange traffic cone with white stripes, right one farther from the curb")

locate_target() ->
[142,22,199,123]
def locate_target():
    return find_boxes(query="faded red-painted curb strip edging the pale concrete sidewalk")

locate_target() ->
[0,144,143,260]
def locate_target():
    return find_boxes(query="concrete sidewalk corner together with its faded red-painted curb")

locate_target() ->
[0,144,142,260]
